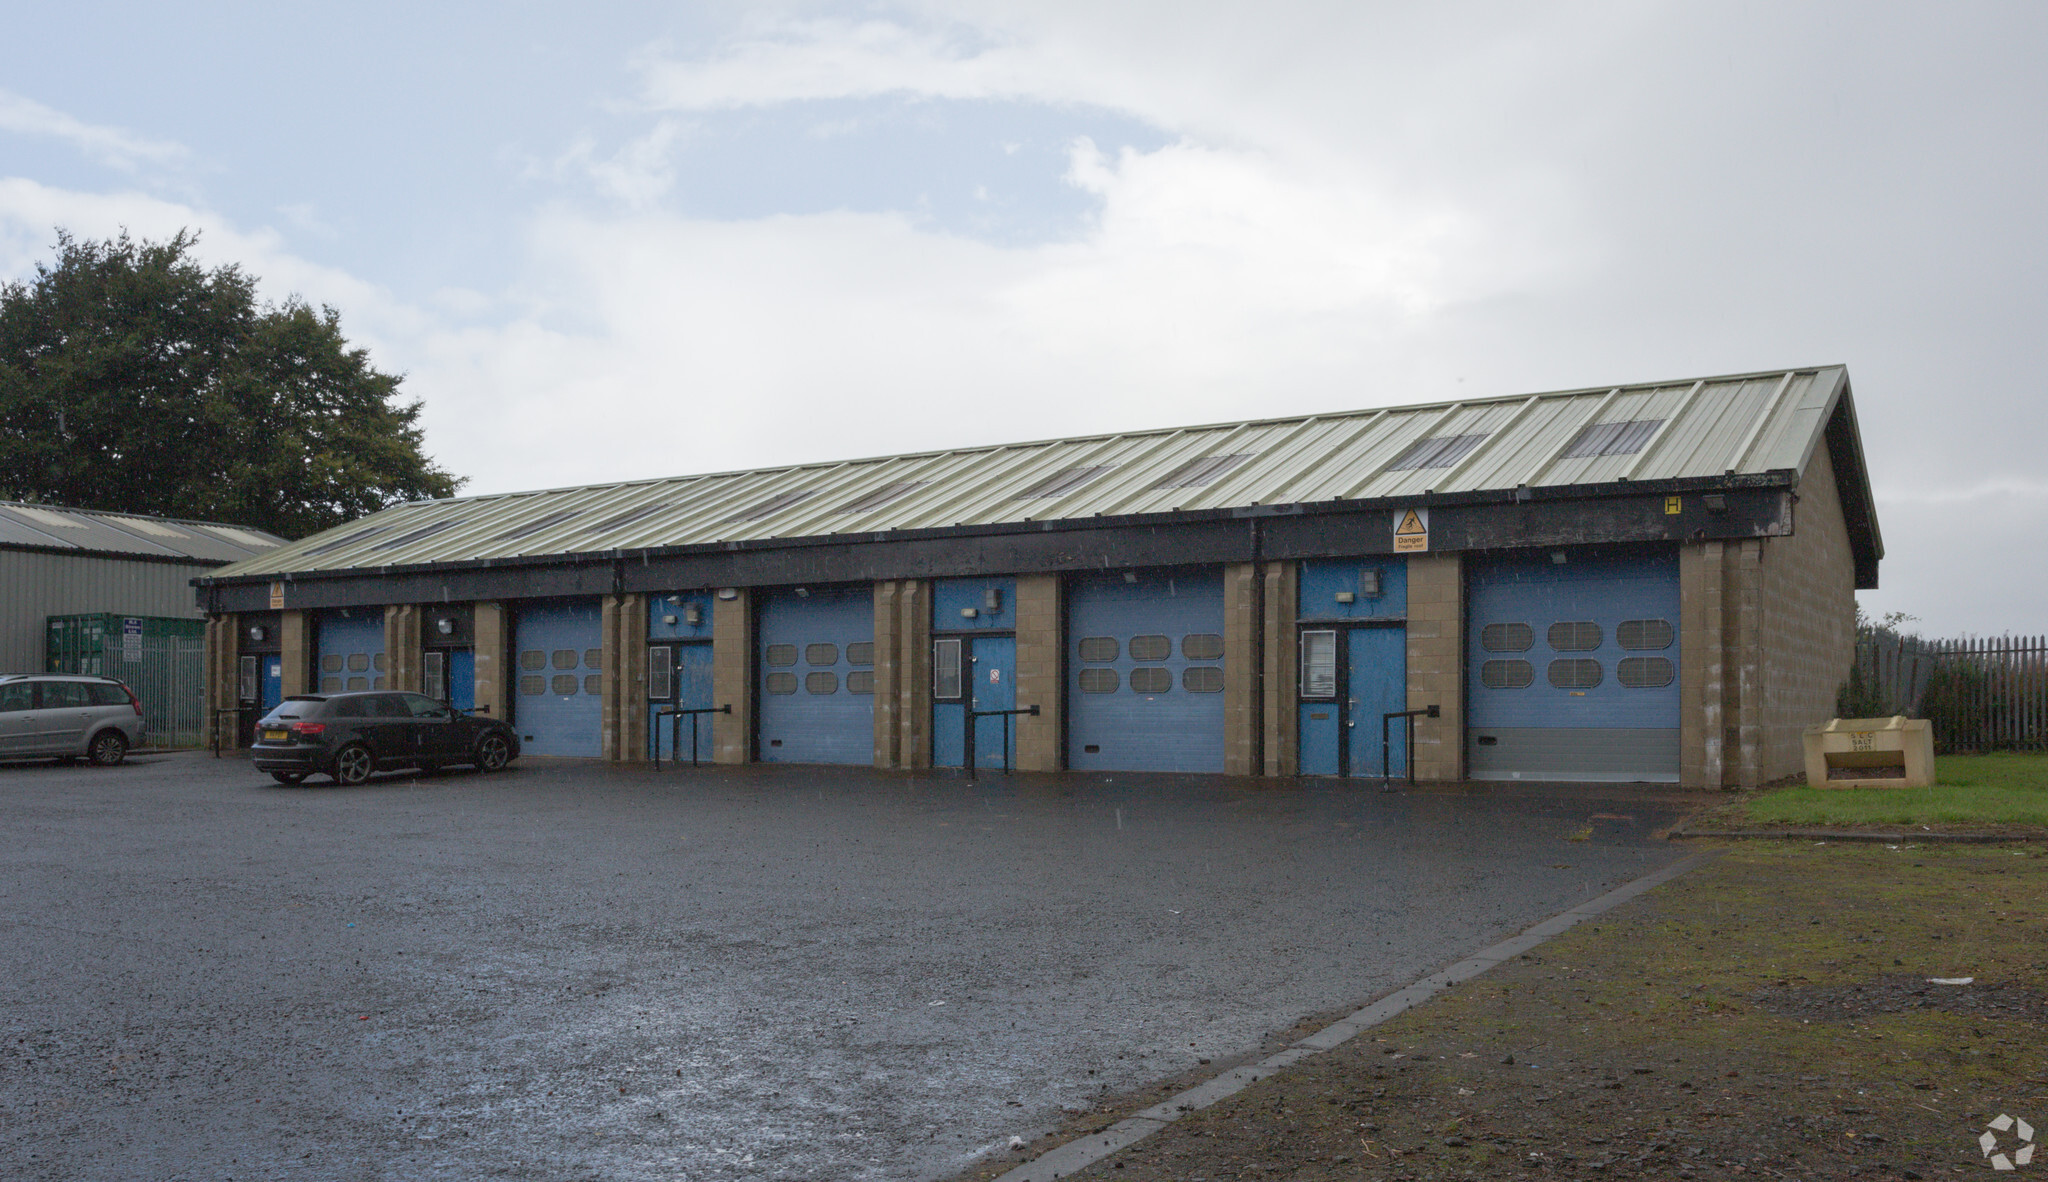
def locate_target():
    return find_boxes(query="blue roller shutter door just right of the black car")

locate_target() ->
[512,600,604,758]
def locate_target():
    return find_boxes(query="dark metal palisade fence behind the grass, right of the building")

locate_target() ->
[1843,631,2048,752]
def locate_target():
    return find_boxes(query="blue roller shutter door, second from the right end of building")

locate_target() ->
[1067,569,1223,772]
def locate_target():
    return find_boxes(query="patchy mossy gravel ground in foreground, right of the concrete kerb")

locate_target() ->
[971,844,2048,1182]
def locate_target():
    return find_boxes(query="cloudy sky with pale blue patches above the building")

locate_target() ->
[0,0,2048,633]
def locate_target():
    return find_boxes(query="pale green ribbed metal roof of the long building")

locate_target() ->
[215,367,1875,578]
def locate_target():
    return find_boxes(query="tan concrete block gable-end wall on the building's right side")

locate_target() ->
[1755,449,1855,783]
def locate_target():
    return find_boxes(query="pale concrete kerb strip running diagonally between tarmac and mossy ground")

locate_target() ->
[995,850,1720,1182]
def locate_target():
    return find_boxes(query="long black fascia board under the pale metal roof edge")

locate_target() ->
[193,471,1792,613]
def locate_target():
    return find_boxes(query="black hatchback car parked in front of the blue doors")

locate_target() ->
[250,692,518,785]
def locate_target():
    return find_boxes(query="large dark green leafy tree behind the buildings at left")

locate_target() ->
[0,229,463,537]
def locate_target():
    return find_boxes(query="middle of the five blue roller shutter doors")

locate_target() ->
[756,586,874,764]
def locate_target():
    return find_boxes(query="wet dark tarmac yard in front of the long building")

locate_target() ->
[0,754,1696,1182]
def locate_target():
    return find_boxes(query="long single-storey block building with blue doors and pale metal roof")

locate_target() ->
[195,367,1882,785]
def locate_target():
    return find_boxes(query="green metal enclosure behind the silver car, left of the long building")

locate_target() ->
[43,613,207,748]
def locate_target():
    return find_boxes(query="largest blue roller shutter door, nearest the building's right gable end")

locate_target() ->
[1466,553,1679,783]
